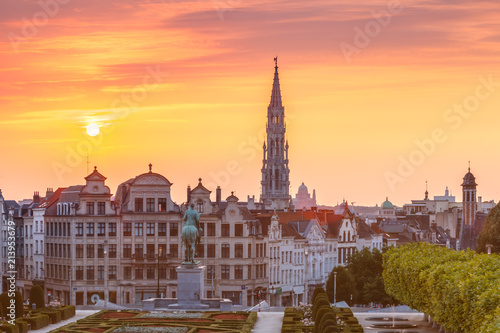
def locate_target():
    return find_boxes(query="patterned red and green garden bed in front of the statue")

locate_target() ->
[53,310,257,333]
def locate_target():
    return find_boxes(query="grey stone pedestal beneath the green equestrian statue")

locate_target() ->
[168,264,209,310]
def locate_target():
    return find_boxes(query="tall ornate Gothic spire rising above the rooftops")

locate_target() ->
[260,57,291,209]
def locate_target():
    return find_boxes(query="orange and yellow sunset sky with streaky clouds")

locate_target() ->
[0,0,500,205]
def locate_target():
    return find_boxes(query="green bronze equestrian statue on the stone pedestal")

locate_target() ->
[181,203,202,264]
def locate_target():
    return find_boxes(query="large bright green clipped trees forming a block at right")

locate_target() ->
[383,243,500,333]
